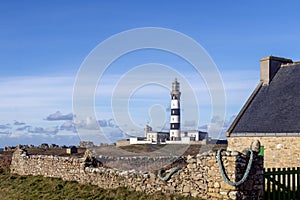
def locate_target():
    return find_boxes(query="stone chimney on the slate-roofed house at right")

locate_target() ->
[260,56,293,85]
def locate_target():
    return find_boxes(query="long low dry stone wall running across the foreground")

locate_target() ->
[11,146,263,199]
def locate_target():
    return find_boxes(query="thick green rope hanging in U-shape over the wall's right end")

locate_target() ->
[217,148,253,186]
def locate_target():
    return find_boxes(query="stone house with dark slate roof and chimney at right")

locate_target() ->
[226,56,300,168]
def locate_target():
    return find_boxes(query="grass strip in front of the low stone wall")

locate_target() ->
[0,168,199,200]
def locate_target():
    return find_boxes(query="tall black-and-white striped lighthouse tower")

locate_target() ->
[170,78,181,141]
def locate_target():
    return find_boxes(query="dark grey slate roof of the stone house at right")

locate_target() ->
[227,63,300,136]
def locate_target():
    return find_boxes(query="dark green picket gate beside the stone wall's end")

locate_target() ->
[263,167,300,200]
